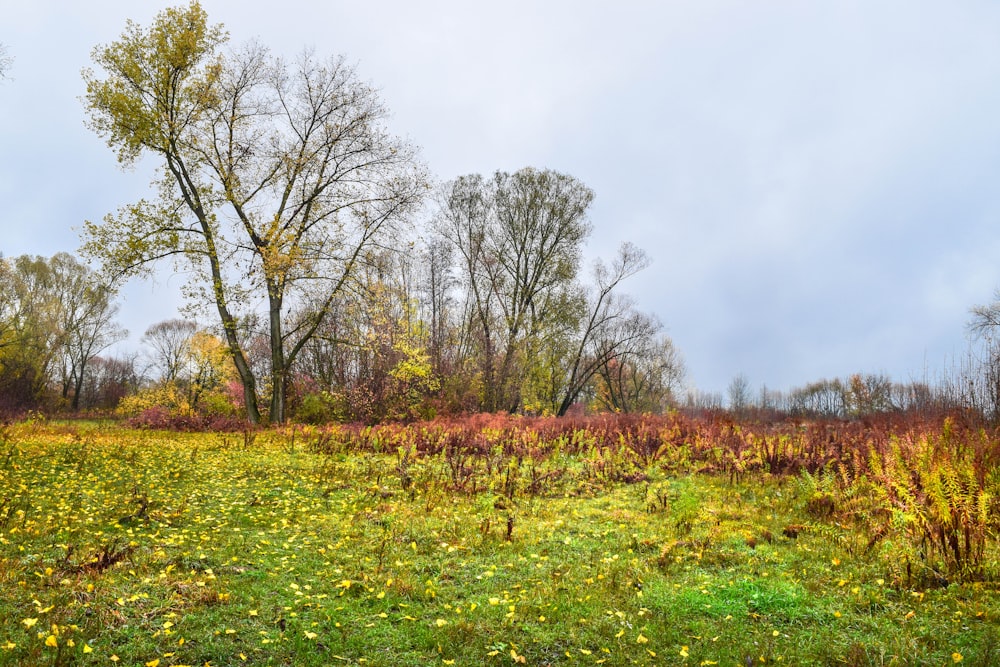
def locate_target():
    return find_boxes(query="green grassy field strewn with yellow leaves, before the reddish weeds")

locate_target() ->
[0,423,1000,667]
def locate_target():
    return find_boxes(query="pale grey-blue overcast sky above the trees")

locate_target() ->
[0,0,1000,393]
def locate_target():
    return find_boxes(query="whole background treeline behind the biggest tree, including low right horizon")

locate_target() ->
[0,245,1000,426]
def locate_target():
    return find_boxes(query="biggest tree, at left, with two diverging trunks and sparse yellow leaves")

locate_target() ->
[83,2,426,422]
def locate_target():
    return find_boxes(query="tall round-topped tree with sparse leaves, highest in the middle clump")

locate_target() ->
[438,168,594,412]
